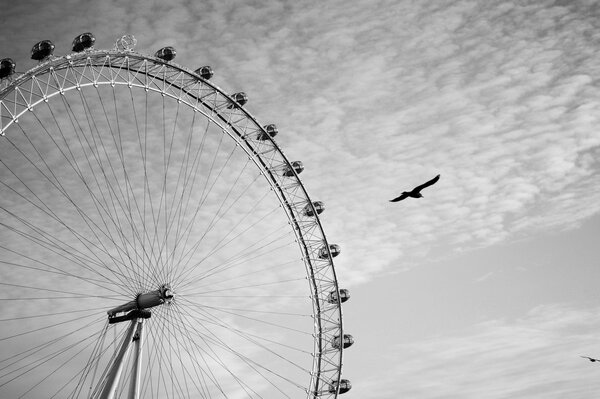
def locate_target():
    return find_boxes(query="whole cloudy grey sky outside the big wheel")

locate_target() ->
[0,0,600,399]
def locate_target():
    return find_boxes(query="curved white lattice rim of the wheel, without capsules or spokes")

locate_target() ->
[0,38,344,397]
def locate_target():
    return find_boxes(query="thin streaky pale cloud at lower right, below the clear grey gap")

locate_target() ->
[354,304,600,399]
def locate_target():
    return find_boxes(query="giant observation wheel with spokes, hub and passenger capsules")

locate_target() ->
[0,33,353,399]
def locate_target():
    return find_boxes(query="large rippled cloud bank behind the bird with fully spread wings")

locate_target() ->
[3,1,600,288]
